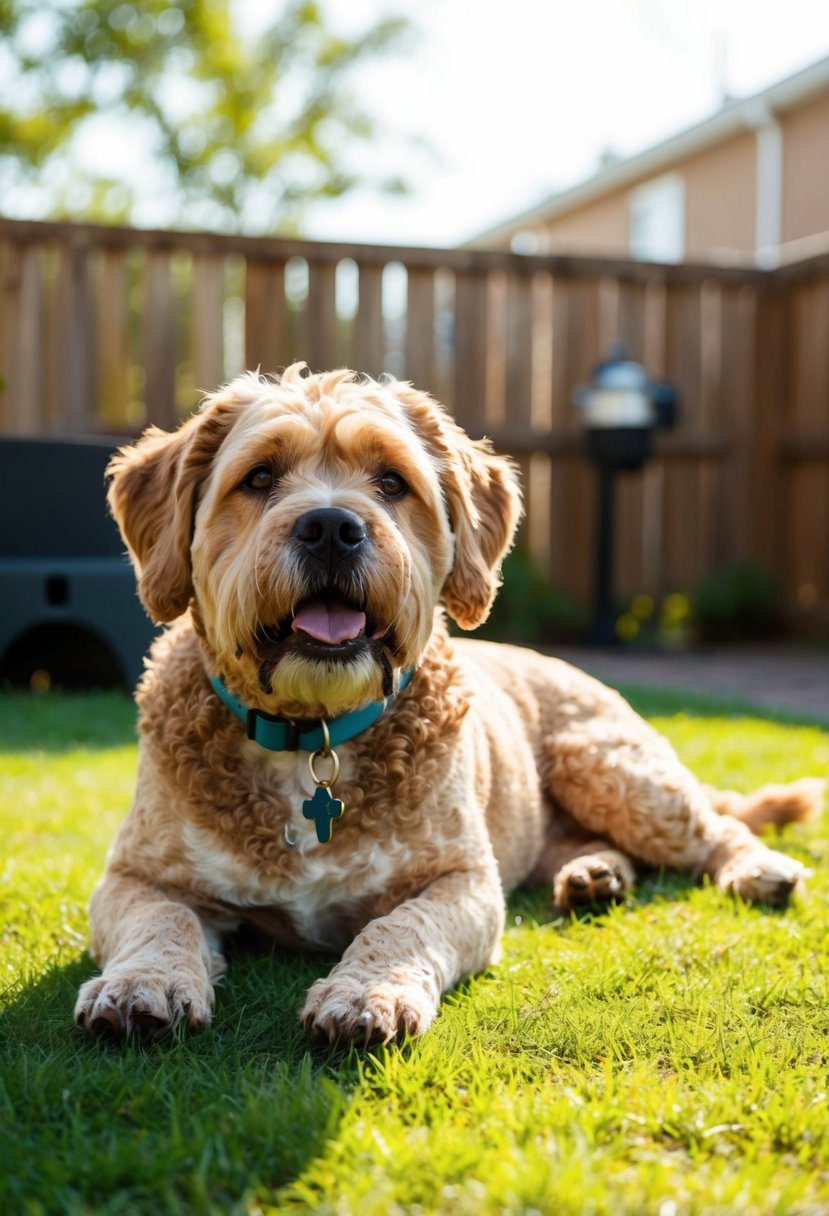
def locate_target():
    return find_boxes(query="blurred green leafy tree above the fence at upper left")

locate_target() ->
[0,0,408,232]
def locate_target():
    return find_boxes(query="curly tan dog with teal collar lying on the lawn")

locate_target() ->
[75,364,822,1043]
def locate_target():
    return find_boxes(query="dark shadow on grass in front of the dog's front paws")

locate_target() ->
[0,950,359,1214]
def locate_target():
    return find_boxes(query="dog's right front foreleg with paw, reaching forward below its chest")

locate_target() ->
[300,863,504,1043]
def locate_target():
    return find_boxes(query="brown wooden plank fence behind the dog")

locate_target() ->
[0,220,829,629]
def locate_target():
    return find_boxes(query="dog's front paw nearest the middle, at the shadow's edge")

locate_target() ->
[299,972,438,1045]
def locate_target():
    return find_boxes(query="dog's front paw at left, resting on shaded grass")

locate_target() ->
[75,969,213,1038]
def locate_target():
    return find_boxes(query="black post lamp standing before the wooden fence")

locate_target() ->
[573,342,677,646]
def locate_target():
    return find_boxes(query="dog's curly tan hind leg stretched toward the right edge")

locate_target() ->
[545,716,806,903]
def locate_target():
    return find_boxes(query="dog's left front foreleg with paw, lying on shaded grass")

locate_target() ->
[75,877,224,1038]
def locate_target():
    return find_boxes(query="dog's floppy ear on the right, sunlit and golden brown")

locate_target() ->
[396,384,521,629]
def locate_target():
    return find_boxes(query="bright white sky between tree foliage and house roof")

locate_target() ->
[286,0,829,246]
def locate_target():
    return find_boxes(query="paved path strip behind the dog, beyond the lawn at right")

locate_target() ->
[554,646,829,722]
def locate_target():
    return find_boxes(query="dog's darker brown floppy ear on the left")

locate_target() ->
[107,395,237,623]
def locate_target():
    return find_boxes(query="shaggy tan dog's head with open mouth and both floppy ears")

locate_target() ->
[109,364,520,717]
